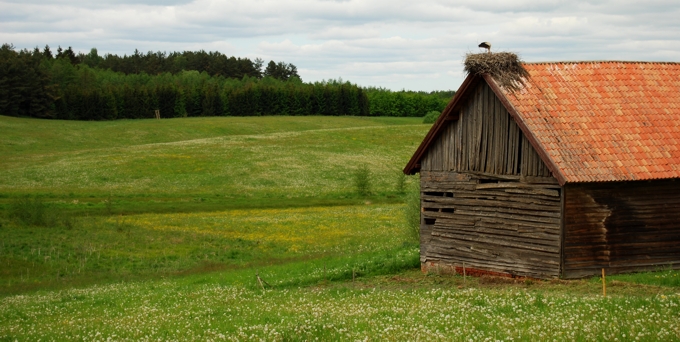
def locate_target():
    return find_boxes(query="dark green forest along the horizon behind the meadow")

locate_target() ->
[0,44,453,120]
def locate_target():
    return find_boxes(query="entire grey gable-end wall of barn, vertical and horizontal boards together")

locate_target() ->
[420,82,561,278]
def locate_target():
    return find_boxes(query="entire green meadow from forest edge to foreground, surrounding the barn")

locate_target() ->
[0,116,680,341]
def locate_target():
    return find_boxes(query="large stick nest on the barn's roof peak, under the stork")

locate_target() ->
[465,52,530,92]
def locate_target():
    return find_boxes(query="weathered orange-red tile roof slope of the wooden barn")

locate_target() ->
[502,62,680,183]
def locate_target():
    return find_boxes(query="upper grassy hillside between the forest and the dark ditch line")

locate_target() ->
[0,117,428,204]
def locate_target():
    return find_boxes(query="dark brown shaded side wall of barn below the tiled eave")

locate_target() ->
[563,180,680,278]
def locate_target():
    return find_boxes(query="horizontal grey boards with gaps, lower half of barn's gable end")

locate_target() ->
[420,171,561,278]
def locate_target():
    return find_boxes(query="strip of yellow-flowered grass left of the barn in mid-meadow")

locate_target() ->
[103,204,405,253]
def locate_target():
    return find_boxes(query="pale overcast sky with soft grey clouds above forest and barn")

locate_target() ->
[0,0,680,91]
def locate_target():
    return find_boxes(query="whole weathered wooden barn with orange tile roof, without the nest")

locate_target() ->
[404,57,680,278]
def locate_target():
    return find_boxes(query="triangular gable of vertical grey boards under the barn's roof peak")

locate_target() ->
[421,82,551,177]
